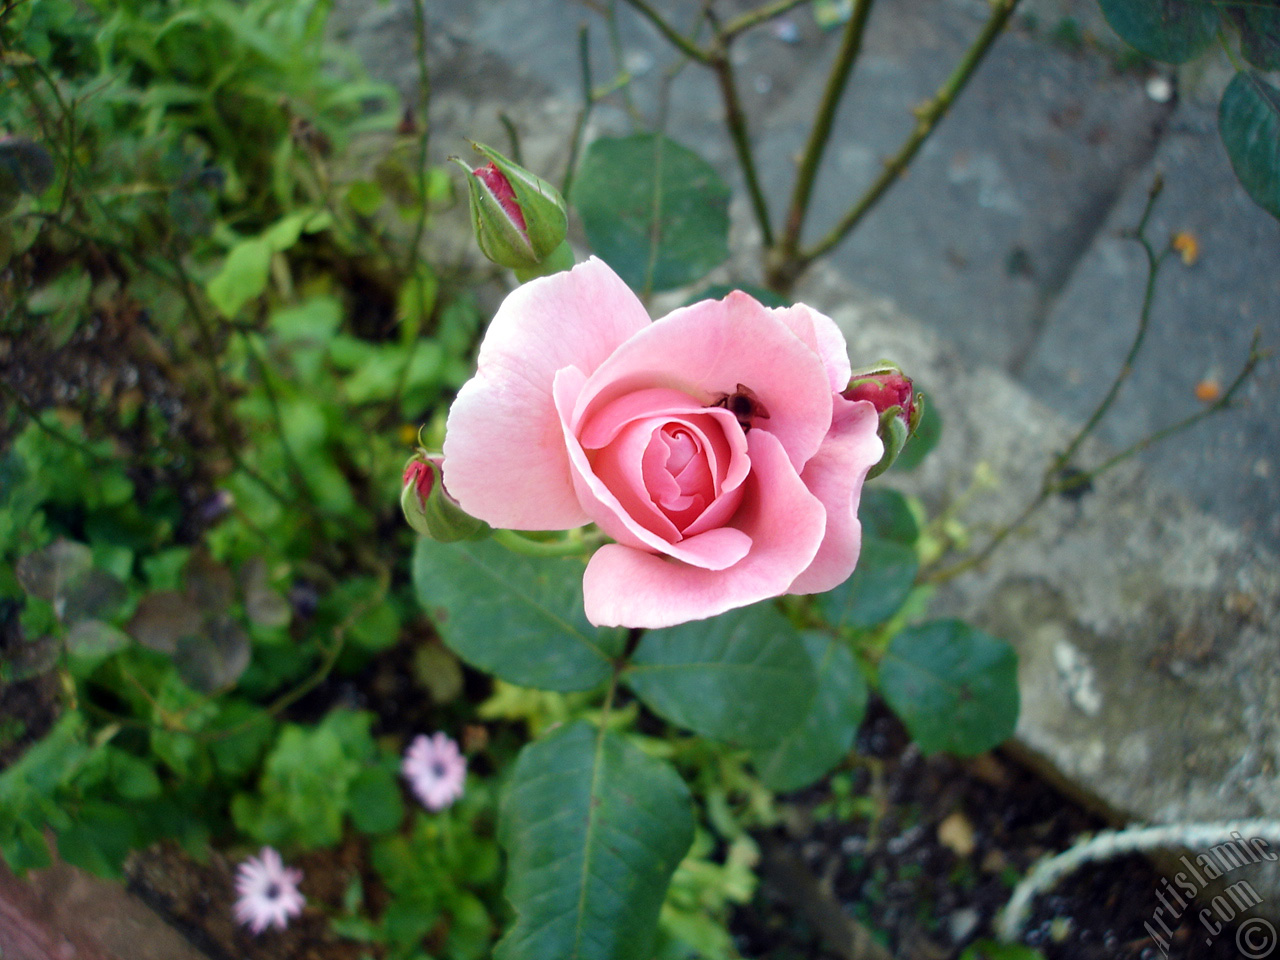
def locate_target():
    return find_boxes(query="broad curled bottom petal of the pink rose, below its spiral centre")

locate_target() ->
[582,430,829,627]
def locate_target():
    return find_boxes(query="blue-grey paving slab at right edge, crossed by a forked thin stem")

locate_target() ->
[1020,99,1280,552]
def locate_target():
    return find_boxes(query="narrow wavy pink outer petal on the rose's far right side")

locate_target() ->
[787,399,884,594]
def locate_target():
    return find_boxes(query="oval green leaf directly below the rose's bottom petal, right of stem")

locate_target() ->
[625,603,817,748]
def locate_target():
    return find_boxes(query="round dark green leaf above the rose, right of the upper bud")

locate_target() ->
[572,133,728,293]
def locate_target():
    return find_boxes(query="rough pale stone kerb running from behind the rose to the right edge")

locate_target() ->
[799,261,1280,911]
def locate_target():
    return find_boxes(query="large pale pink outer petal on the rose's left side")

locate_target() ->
[444,257,649,530]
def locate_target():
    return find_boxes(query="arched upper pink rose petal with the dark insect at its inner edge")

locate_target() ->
[573,292,838,470]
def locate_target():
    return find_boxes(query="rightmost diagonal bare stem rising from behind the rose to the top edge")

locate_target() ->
[774,0,1018,285]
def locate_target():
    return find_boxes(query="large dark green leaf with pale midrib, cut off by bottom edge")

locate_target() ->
[494,721,694,960]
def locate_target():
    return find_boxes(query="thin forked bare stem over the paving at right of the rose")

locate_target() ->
[918,177,1266,584]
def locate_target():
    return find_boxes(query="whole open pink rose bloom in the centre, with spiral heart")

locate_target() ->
[444,257,882,627]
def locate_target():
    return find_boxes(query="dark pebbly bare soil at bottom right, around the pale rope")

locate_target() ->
[735,707,1240,960]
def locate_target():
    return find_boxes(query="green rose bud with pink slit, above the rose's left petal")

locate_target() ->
[457,143,573,279]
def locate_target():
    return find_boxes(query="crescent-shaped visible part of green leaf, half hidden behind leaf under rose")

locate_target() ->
[751,632,867,791]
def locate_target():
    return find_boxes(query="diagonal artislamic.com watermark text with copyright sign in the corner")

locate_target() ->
[1143,831,1280,960]
